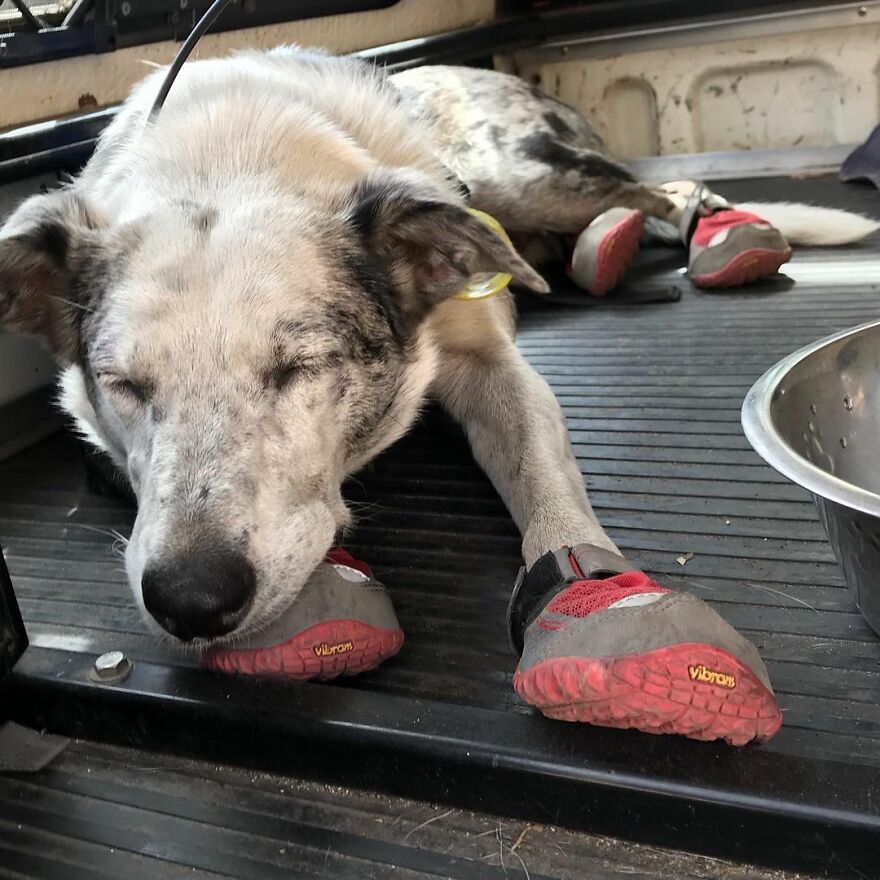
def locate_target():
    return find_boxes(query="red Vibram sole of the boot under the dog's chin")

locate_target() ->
[202,620,403,681]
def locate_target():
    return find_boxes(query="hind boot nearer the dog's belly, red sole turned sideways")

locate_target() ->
[566,208,645,296]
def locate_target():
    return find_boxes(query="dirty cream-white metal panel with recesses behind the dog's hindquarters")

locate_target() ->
[505,3,880,158]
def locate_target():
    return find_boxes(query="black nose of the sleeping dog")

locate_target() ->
[141,549,257,642]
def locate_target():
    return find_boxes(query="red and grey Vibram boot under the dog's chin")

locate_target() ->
[202,547,403,681]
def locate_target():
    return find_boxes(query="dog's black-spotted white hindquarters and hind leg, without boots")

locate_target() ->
[391,66,678,235]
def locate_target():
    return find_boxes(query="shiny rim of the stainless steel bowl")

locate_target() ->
[740,320,880,517]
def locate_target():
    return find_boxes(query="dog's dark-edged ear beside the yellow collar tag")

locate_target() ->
[351,179,549,317]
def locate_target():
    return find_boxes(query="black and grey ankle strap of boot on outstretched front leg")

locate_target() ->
[507,544,638,654]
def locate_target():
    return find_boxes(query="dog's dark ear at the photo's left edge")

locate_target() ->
[0,190,103,363]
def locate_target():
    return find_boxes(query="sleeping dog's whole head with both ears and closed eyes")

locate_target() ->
[0,172,546,641]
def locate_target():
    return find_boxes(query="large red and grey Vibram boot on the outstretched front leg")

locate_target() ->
[508,544,782,745]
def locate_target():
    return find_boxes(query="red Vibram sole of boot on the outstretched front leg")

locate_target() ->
[513,643,782,746]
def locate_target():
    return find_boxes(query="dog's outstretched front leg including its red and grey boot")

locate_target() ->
[434,303,782,744]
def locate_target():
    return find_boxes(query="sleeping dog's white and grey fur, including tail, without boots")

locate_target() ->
[0,48,875,642]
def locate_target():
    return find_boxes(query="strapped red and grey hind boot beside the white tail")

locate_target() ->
[661,180,791,287]
